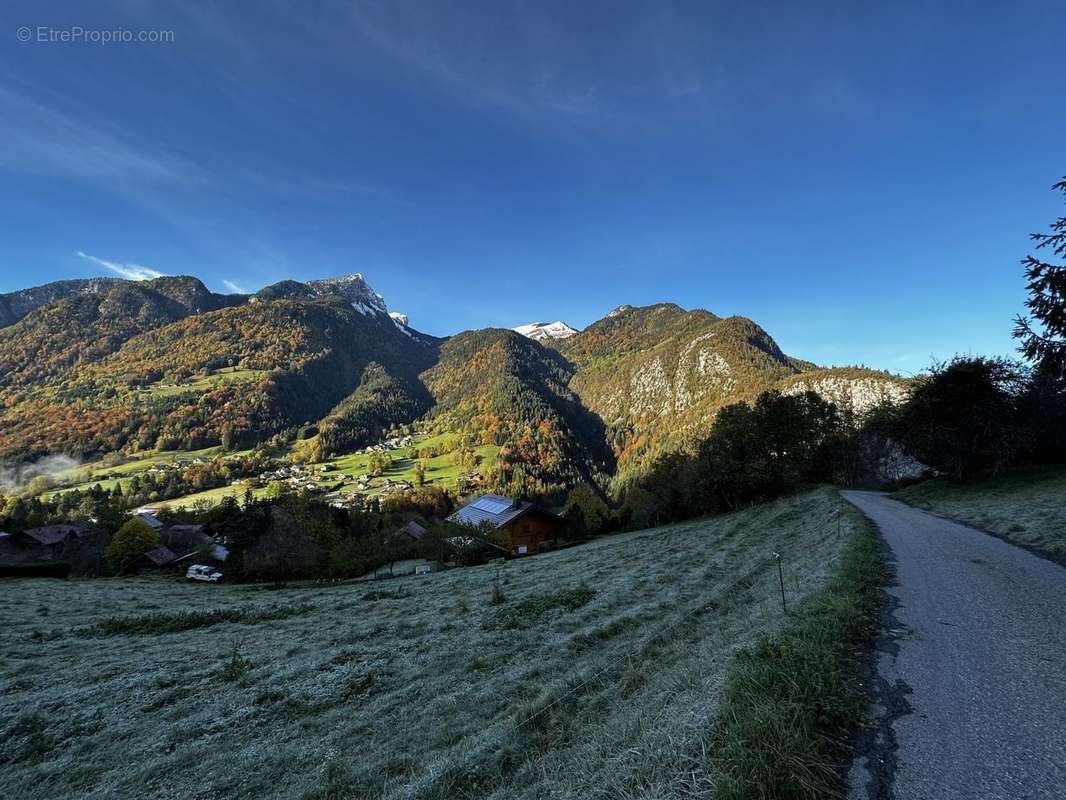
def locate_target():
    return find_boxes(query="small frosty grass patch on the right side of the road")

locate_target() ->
[893,466,1066,558]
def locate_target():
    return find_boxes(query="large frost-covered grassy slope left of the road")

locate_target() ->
[0,490,861,800]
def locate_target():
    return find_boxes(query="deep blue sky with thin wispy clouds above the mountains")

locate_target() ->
[0,0,1066,372]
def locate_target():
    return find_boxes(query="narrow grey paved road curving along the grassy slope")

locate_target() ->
[842,492,1066,800]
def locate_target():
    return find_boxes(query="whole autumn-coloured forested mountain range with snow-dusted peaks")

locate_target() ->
[0,274,906,492]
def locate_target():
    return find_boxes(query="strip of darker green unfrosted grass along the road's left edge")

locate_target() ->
[713,509,889,800]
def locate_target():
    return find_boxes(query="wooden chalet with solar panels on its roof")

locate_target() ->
[448,495,566,556]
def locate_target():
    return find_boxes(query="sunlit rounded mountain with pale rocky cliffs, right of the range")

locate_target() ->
[549,304,907,482]
